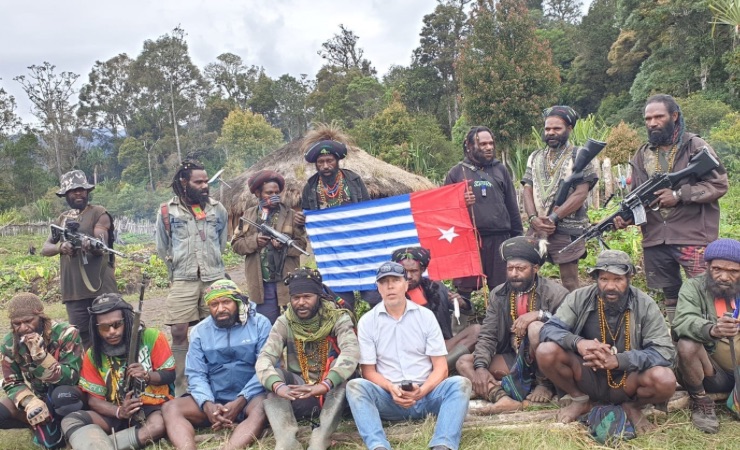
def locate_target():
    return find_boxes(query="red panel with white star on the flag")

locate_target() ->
[410,183,483,280]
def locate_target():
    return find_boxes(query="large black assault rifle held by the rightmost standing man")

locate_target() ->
[560,147,719,253]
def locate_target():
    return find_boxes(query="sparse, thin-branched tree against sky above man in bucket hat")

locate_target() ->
[13,61,79,177]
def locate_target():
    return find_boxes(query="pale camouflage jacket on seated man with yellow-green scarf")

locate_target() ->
[255,314,360,391]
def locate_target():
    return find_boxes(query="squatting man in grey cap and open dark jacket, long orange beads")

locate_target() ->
[537,250,676,434]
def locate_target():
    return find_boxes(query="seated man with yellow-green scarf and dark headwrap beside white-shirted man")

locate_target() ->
[257,268,360,450]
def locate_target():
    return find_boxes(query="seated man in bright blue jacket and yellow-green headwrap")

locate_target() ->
[162,280,270,450]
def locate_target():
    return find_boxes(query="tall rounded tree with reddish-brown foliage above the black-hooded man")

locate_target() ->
[457,0,559,141]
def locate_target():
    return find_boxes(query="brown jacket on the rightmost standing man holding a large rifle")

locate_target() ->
[630,133,728,247]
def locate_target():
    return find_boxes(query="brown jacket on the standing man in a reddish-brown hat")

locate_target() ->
[231,203,306,306]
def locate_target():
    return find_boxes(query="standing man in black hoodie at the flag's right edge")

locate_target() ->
[445,126,523,298]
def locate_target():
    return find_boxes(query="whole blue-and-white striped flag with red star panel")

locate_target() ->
[304,183,483,292]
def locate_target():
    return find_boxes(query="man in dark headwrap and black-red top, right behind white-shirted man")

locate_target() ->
[391,247,480,369]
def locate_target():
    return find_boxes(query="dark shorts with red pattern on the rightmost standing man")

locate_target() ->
[644,244,707,289]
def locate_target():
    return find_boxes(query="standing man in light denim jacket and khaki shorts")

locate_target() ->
[156,161,228,396]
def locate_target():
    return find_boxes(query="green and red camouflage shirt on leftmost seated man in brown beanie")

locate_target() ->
[2,321,83,404]
